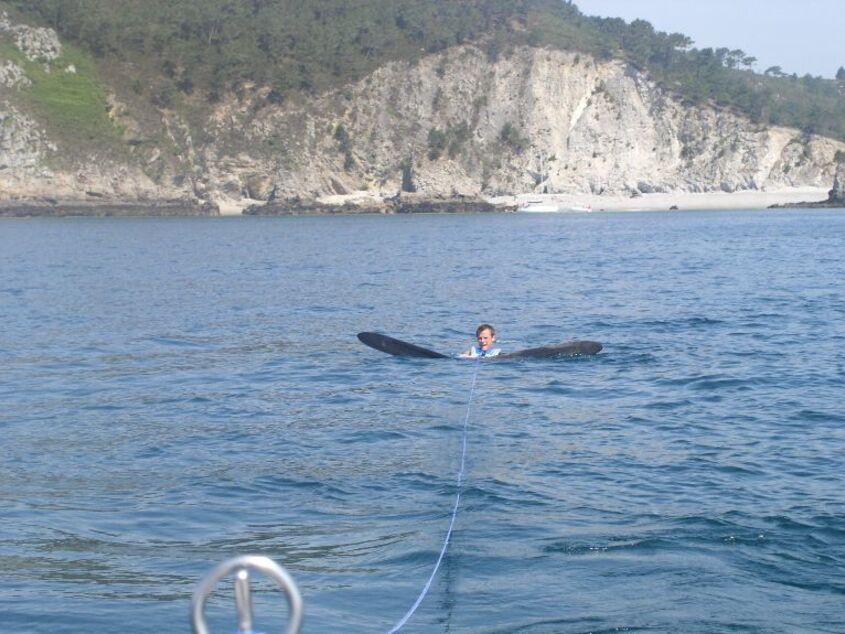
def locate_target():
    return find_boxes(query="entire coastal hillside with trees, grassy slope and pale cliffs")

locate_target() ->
[0,0,845,215]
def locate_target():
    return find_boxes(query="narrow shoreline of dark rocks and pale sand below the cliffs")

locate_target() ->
[0,187,835,218]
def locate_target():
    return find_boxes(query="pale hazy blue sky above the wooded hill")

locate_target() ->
[575,0,845,78]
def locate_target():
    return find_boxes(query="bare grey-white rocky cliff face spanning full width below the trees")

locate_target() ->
[0,13,845,210]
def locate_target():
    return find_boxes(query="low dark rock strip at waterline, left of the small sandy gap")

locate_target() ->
[0,198,220,218]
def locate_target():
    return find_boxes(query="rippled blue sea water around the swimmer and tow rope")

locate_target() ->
[0,210,845,634]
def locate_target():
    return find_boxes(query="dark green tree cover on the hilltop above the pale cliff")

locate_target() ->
[0,0,845,141]
